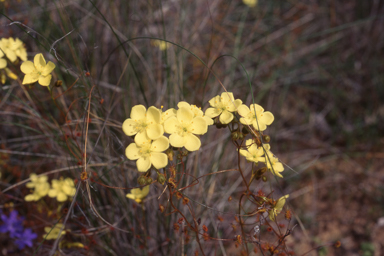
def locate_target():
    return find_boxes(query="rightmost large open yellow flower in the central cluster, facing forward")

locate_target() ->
[164,107,208,151]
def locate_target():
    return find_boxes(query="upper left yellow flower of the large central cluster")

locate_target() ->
[122,105,164,143]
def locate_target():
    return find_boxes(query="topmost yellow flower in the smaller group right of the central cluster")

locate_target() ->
[205,92,243,124]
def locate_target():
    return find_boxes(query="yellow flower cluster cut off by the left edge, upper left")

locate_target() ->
[0,37,27,84]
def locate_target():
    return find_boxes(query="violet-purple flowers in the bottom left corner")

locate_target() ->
[0,210,37,250]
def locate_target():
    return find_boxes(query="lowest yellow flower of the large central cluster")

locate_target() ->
[125,134,169,172]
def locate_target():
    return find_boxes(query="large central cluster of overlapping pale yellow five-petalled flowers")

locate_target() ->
[122,102,213,172]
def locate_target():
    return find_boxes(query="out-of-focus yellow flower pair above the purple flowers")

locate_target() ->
[24,173,76,202]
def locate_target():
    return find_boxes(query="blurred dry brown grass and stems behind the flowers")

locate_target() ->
[0,0,384,255]
